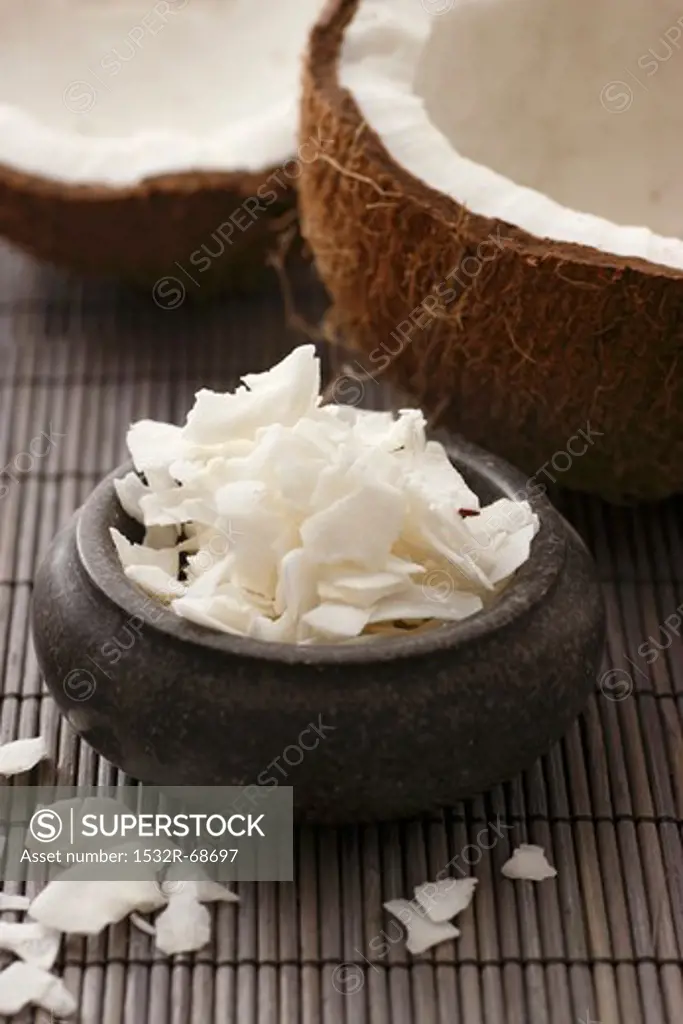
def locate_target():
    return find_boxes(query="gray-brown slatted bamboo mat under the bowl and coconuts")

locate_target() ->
[0,239,683,1024]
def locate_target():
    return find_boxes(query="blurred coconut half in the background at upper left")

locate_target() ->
[0,0,322,290]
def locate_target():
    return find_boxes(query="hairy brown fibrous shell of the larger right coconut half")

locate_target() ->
[299,0,683,501]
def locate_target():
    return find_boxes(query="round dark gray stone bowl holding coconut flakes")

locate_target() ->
[33,440,604,822]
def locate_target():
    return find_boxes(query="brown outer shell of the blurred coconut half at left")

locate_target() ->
[0,165,296,296]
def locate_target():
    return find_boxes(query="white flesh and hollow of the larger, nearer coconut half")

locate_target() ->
[340,0,683,268]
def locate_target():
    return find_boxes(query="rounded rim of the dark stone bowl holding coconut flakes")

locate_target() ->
[76,430,572,666]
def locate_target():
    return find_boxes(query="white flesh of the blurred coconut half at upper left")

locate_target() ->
[0,0,323,185]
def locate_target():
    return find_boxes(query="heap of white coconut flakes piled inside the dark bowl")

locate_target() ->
[112,345,539,644]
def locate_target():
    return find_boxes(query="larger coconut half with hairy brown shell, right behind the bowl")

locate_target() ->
[299,0,683,500]
